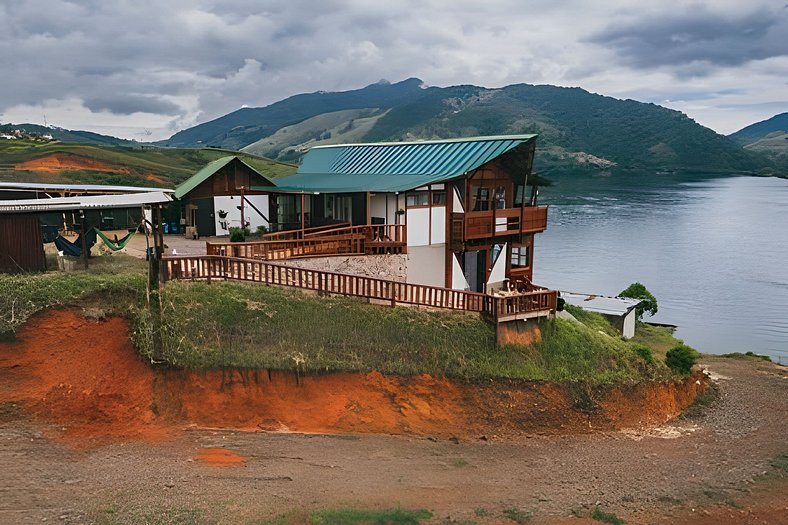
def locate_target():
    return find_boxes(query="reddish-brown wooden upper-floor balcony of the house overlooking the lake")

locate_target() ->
[464,206,547,240]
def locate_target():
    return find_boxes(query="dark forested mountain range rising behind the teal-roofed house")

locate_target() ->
[163,78,775,173]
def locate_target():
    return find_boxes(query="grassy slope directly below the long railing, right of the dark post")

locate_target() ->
[135,282,666,383]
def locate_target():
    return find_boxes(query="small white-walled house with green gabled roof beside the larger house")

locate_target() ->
[175,155,274,237]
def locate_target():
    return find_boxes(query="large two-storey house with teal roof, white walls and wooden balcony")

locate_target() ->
[258,135,547,292]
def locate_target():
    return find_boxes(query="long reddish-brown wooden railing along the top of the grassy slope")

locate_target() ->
[162,255,557,320]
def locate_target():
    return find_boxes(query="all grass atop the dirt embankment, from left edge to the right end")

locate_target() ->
[0,254,688,384]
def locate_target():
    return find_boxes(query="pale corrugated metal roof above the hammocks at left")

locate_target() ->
[0,191,172,213]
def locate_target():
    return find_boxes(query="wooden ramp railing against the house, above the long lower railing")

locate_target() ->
[205,224,407,261]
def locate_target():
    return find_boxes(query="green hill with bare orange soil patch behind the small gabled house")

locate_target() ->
[0,139,296,188]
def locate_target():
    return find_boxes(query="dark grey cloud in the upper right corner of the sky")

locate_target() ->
[586,8,788,69]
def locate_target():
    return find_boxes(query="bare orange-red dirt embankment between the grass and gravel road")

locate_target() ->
[0,310,705,445]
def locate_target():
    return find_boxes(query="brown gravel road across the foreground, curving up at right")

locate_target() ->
[0,358,788,525]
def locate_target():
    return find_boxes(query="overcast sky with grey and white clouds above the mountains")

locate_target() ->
[0,0,788,140]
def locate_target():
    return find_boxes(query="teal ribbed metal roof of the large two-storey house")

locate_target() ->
[270,135,536,193]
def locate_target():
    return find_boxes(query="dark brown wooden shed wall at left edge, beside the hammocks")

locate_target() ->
[0,213,46,273]
